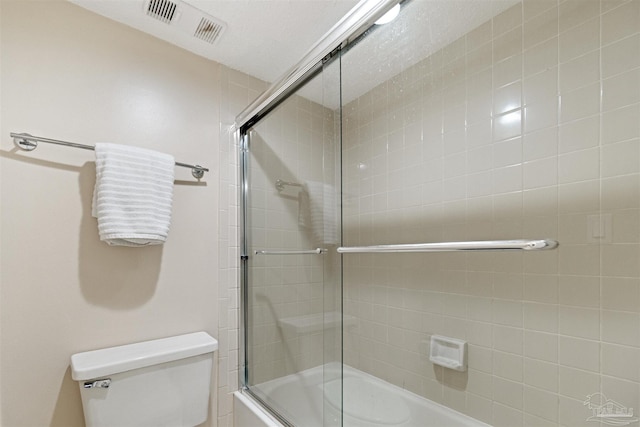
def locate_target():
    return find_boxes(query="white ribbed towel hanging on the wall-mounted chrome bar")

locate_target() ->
[92,143,175,247]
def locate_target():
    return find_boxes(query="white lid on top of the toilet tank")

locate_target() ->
[71,332,218,381]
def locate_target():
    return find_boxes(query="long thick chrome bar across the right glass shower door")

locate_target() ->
[337,240,558,254]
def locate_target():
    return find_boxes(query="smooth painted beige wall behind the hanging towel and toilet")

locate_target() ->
[0,0,222,427]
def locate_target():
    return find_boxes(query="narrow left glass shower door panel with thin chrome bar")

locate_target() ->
[242,57,342,427]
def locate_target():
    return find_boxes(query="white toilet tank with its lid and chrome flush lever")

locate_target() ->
[71,332,218,427]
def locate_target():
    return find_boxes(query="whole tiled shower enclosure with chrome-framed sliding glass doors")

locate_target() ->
[238,0,640,427]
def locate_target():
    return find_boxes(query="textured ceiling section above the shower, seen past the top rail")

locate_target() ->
[300,0,519,109]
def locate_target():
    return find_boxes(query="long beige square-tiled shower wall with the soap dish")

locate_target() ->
[342,0,640,427]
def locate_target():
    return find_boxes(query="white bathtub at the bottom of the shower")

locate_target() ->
[234,366,489,427]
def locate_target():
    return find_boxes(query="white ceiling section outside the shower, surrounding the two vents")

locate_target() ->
[70,0,357,82]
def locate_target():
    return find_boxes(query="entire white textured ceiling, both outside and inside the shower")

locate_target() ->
[69,0,519,108]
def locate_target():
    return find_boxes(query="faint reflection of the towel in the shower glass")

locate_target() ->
[303,181,338,245]
